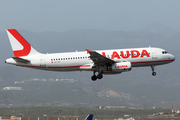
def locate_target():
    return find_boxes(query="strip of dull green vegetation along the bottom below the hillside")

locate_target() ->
[0,107,171,120]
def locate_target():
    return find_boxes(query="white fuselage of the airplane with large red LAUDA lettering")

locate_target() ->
[6,47,175,74]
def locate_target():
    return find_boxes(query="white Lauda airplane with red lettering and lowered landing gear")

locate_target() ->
[5,29,175,81]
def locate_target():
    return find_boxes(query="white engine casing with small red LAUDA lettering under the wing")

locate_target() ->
[112,62,131,72]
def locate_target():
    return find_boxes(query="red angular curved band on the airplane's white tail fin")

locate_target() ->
[7,29,31,57]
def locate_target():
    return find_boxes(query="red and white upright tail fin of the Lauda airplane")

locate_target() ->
[7,29,39,57]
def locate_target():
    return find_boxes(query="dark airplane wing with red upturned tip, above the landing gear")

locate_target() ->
[86,49,115,65]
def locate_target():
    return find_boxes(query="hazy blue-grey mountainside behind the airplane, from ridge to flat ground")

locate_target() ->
[0,24,180,108]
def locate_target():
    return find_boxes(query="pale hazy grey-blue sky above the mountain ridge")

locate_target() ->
[0,0,180,32]
